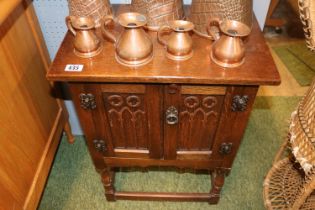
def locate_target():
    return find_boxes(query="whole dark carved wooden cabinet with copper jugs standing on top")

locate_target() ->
[47,5,280,203]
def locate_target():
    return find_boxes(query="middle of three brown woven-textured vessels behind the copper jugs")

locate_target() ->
[131,0,185,30]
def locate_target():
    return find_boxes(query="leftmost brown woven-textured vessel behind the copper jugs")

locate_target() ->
[68,0,112,27]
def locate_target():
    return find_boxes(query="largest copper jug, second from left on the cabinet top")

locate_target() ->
[103,12,153,66]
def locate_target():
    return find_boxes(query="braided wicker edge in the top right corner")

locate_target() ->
[298,0,315,51]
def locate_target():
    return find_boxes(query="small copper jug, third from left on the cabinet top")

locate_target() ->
[158,20,194,61]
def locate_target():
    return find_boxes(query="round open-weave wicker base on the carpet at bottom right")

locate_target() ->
[263,158,315,210]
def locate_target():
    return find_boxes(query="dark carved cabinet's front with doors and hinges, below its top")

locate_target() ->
[69,83,258,202]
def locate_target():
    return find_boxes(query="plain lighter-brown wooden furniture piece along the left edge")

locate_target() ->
[0,0,71,210]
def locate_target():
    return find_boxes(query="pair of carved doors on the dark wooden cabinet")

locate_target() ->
[70,84,232,159]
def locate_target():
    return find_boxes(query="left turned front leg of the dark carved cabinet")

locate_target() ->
[102,168,116,201]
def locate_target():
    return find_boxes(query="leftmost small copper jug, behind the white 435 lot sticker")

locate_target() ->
[66,16,102,58]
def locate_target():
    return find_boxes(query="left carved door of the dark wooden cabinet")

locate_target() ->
[70,84,163,158]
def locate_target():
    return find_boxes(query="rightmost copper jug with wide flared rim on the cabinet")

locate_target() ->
[208,19,251,68]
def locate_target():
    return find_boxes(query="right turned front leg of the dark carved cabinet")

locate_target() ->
[209,170,225,204]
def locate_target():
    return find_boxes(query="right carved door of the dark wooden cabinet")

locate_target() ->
[164,85,226,159]
